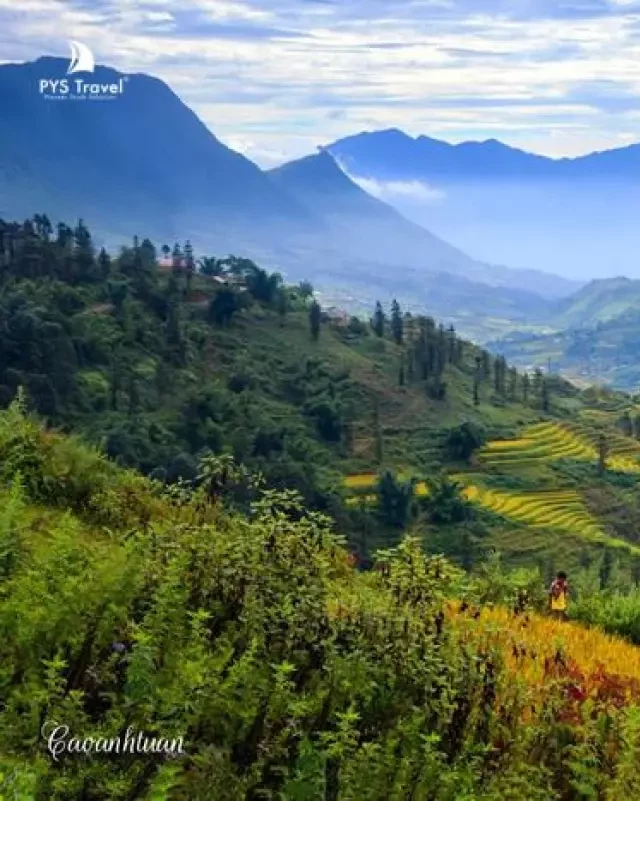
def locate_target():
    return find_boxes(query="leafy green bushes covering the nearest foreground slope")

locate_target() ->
[0,382,638,805]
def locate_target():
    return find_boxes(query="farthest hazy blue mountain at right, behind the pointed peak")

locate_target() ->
[328,129,640,278]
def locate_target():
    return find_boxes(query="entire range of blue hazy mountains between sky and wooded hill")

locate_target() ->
[5,57,640,340]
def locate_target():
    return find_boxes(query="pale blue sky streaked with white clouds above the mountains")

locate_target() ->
[0,0,640,167]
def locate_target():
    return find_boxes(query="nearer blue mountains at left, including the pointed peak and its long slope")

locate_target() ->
[0,57,577,334]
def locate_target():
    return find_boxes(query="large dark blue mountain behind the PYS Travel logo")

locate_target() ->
[0,58,318,249]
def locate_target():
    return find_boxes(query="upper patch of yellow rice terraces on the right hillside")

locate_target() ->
[478,421,640,475]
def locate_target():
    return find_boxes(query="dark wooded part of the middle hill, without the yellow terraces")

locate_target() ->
[0,215,568,492]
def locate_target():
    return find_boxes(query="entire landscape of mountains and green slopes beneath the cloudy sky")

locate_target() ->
[0,48,640,807]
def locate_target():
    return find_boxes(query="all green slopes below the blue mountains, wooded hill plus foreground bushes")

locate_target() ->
[6,217,640,806]
